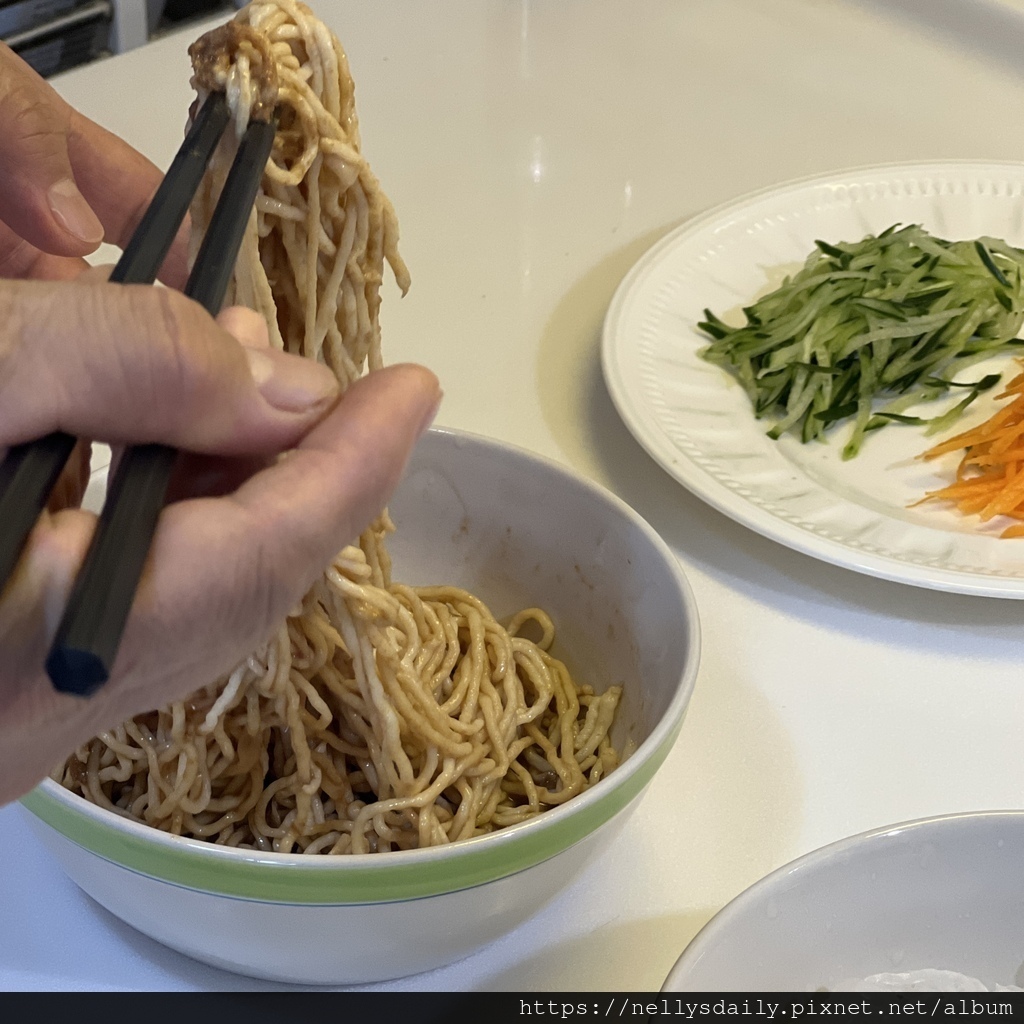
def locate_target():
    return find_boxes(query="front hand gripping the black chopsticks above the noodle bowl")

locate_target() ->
[0,282,439,804]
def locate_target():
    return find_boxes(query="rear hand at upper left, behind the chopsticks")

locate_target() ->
[0,43,187,288]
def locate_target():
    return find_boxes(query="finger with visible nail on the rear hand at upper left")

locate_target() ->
[0,47,103,256]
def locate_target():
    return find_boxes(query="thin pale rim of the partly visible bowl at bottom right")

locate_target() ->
[660,808,1024,992]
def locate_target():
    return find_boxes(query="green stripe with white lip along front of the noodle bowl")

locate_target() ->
[22,716,682,904]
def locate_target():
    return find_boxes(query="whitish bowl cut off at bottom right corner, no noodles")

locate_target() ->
[663,811,1024,992]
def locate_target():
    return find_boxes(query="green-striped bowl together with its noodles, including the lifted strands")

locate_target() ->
[25,0,698,983]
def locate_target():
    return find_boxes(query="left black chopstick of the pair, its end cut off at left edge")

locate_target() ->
[0,93,229,602]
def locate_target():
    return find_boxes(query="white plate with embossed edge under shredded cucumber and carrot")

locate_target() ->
[601,155,1024,598]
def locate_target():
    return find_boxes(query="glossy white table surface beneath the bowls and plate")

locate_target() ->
[6,0,1024,991]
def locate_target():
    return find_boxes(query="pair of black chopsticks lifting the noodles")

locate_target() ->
[0,93,275,695]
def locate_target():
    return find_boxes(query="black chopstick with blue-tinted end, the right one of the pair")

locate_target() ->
[46,116,275,696]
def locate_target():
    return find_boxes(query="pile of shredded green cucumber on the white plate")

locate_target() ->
[698,224,1024,459]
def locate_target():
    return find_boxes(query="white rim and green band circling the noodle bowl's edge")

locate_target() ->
[19,427,700,904]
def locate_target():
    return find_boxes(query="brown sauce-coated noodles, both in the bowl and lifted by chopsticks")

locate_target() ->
[53,0,621,853]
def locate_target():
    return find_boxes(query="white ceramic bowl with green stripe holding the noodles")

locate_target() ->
[23,429,699,984]
